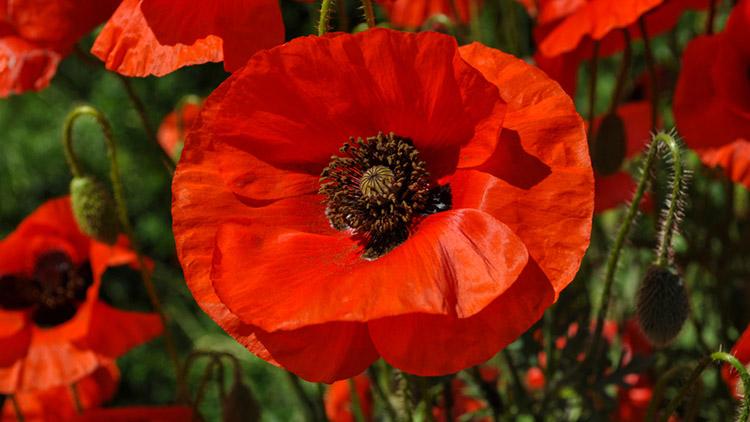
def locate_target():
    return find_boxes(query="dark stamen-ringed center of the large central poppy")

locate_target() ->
[319,133,451,259]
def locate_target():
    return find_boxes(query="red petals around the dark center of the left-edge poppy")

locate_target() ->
[0,197,162,394]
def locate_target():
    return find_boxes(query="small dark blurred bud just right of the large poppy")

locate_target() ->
[591,114,627,176]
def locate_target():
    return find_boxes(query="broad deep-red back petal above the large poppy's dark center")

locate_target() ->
[204,29,503,179]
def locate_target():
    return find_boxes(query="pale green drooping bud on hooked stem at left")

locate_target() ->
[70,176,118,245]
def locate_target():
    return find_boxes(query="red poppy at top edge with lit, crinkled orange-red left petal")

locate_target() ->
[91,0,284,76]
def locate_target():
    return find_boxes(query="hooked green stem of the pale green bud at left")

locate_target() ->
[63,106,186,400]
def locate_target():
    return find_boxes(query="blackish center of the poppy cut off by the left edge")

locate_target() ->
[0,251,93,327]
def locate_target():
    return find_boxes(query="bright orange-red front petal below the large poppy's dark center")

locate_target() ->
[212,209,527,331]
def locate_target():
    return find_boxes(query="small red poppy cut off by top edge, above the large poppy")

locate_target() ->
[380,0,481,28]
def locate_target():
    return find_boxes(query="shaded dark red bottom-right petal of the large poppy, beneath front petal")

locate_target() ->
[368,260,555,376]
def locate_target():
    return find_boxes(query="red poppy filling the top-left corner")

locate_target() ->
[0,0,118,97]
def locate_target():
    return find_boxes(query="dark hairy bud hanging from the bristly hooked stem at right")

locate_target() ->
[637,266,690,346]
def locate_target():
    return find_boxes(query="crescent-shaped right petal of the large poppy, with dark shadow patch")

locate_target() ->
[458,43,594,292]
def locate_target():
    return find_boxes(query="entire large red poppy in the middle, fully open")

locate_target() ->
[172,29,593,382]
